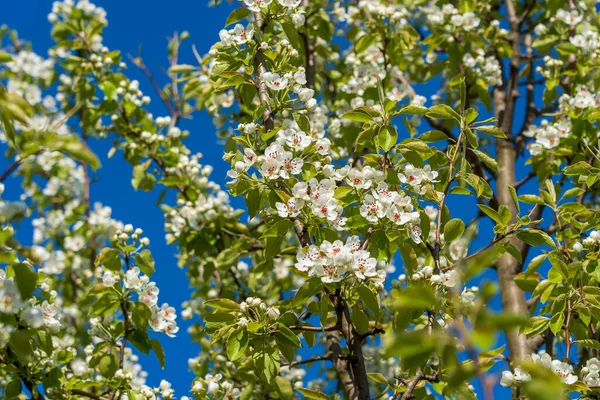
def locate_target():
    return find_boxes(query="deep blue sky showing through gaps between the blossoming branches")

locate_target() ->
[0,0,548,397]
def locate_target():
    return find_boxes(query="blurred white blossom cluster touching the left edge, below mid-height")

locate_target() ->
[0,269,61,332]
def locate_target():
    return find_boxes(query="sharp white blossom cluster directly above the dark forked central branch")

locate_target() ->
[296,236,386,283]
